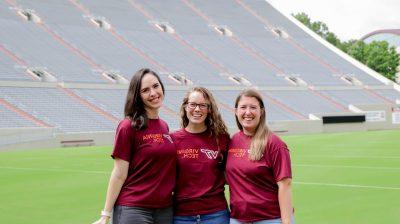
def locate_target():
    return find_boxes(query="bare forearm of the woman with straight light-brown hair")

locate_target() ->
[278,178,293,224]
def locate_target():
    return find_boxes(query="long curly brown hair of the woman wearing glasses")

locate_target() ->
[180,87,229,138]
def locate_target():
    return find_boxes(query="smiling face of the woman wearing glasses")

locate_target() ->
[185,92,210,125]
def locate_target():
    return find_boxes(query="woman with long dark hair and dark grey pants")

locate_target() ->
[95,69,176,224]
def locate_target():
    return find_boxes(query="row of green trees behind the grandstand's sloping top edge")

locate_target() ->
[293,12,400,81]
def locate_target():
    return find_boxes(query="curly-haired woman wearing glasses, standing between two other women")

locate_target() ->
[171,87,229,224]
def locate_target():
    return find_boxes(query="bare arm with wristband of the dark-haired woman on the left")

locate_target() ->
[93,158,129,224]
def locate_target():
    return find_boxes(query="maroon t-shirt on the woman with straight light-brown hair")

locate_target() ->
[226,131,292,222]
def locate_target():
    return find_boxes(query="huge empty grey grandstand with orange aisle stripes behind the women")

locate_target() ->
[0,0,400,147]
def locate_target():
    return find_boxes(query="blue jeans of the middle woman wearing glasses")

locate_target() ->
[174,210,229,224]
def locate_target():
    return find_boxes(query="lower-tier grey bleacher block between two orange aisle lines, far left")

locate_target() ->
[0,87,117,132]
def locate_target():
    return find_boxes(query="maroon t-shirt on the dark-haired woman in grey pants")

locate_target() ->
[111,119,176,208]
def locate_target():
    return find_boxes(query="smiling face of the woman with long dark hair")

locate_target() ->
[140,73,164,110]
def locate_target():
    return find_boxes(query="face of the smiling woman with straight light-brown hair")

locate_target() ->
[235,96,262,135]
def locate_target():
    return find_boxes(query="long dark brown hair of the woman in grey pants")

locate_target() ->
[124,68,165,130]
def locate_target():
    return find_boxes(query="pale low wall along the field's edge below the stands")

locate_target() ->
[0,112,400,151]
